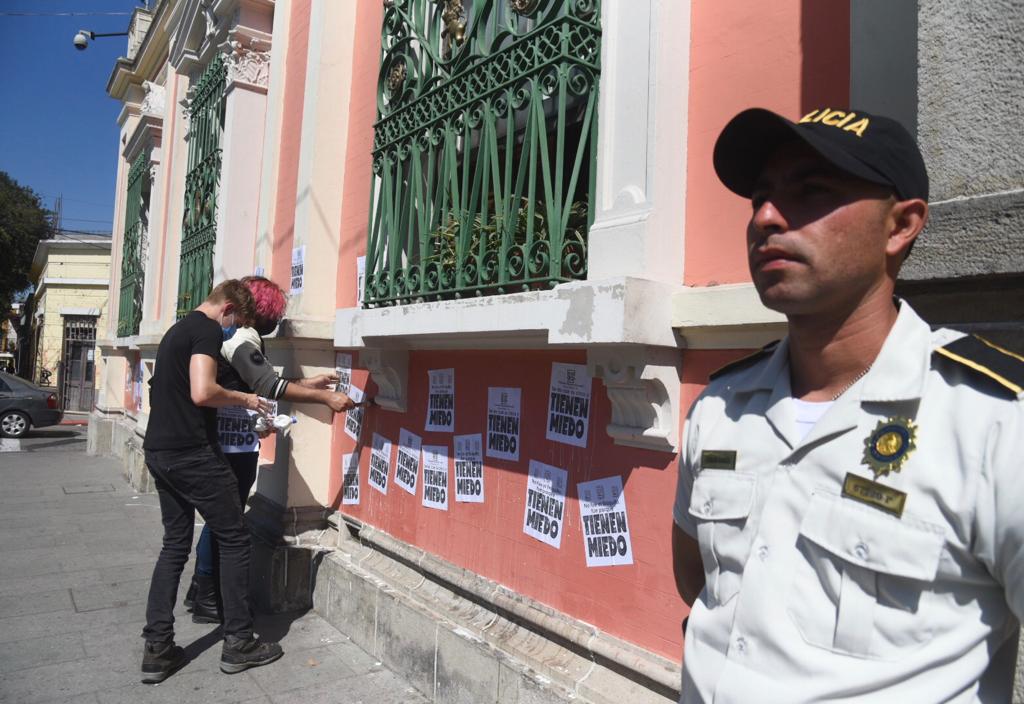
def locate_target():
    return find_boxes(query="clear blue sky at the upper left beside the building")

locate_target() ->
[0,0,140,232]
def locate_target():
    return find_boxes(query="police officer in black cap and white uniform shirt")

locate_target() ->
[673,108,1024,704]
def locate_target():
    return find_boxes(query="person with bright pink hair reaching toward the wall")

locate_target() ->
[184,276,355,623]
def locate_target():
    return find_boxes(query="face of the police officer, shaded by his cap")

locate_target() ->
[746,142,894,315]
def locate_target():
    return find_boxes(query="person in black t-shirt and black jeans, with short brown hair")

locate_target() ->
[142,279,282,684]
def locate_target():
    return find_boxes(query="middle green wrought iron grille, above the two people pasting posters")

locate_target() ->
[177,54,227,318]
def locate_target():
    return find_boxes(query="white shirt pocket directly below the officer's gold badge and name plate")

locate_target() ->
[786,493,944,659]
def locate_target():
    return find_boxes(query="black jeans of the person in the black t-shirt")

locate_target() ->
[142,447,253,643]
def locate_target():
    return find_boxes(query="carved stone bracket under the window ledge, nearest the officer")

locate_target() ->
[587,345,680,452]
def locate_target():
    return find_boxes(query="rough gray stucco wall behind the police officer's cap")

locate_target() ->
[903,0,1024,286]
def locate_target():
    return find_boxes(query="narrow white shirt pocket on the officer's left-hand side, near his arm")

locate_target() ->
[689,470,757,608]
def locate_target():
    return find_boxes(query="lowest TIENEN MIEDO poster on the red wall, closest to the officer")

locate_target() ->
[577,477,633,567]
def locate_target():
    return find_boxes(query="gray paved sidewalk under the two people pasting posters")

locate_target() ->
[0,450,427,704]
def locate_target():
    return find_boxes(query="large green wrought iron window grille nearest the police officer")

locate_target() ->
[364,0,601,307]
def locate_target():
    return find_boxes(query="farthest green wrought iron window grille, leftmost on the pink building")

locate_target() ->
[118,151,150,338]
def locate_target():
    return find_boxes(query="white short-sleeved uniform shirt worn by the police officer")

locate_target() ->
[675,303,1024,704]
